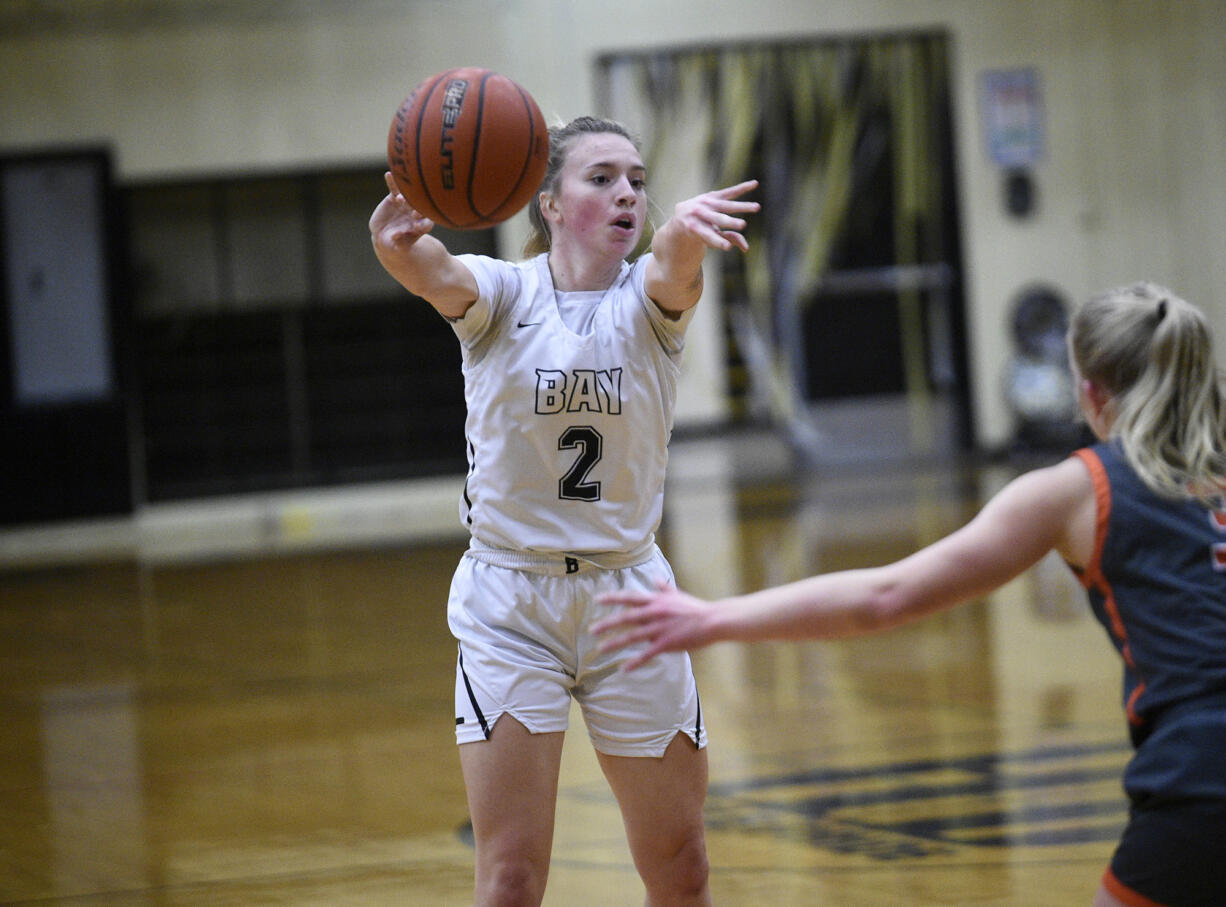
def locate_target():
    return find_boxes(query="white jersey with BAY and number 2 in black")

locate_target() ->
[452,255,689,555]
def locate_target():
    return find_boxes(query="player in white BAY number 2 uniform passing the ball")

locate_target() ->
[370,118,758,905]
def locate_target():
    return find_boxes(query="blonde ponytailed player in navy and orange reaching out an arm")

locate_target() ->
[592,283,1226,907]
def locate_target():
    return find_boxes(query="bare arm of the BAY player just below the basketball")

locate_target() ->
[370,173,477,319]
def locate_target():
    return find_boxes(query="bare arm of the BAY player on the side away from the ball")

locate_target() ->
[644,179,760,315]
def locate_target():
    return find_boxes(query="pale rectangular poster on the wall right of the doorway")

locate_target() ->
[980,67,1043,169]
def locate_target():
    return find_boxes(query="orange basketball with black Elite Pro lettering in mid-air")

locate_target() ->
[387,66,549,230]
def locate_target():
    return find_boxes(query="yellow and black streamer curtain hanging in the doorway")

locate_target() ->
[601,36,945,441]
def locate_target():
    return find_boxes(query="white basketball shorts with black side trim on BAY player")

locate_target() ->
[447,549,706,756]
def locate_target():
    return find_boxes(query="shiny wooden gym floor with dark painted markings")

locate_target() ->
[0,441,1128,907]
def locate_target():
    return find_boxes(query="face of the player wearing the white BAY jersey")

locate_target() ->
[542,132,647,257]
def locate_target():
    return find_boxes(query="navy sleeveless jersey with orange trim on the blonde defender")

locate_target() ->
[1074,442,1226,745]
